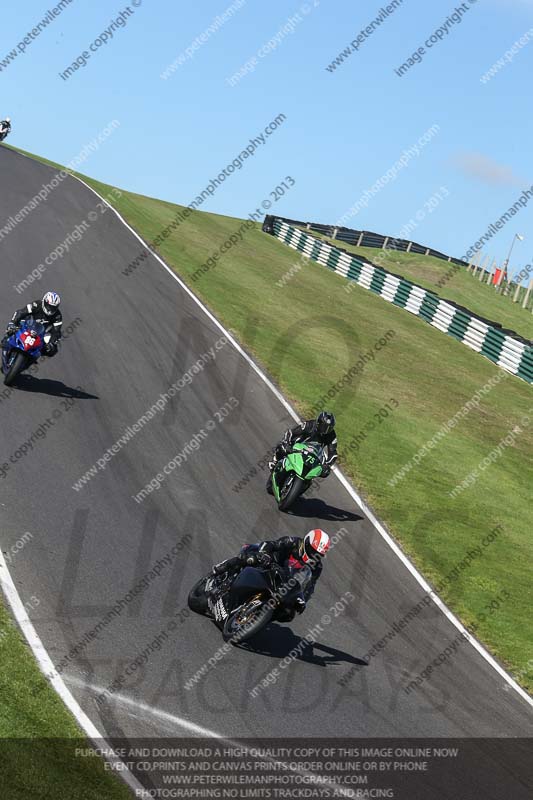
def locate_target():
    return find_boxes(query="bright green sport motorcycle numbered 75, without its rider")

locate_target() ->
[272,442,326,511]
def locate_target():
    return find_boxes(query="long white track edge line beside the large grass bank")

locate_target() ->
[72,175,533,708]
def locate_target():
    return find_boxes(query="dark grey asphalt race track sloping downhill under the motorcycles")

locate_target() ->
[0,148,533,756]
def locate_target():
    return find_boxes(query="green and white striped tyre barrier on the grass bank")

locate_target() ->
[270,217,533,383]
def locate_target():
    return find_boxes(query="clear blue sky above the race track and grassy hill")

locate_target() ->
[0,0,533,271]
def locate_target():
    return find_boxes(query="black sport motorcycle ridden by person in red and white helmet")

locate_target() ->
[188,545,312,644]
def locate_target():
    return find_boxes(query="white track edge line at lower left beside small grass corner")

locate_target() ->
[0,550,144,791]
